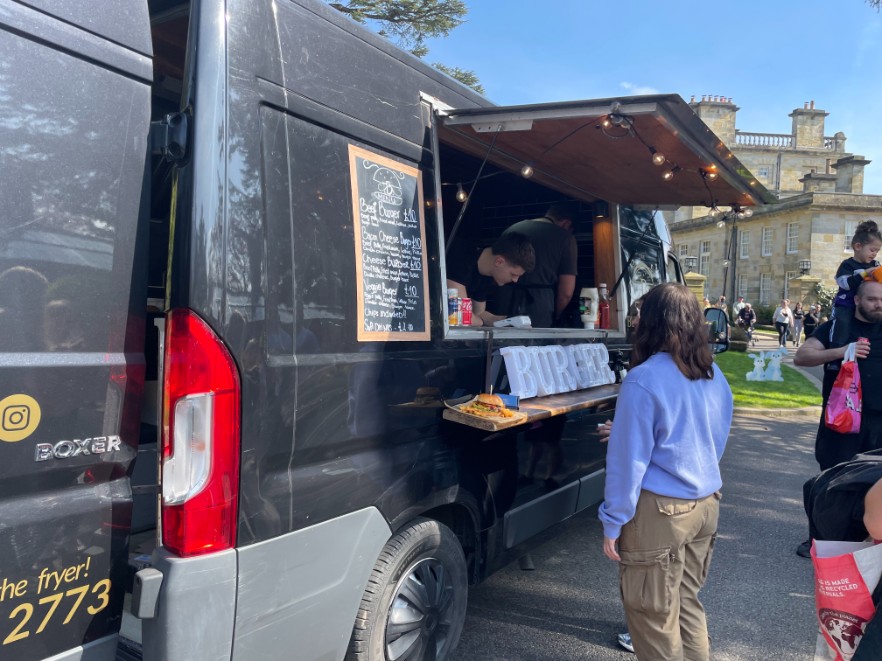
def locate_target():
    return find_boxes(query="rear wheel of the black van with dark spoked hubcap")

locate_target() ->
[346,519,468,661]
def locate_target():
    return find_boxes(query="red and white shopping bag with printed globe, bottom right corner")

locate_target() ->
[812,540,882,661]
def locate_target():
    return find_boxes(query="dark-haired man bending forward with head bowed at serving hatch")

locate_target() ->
[447,232,536,326]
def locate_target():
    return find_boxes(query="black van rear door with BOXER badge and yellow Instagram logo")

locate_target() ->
[0,0,152,661]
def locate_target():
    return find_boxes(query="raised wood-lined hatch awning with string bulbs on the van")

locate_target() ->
[438,94,776,207]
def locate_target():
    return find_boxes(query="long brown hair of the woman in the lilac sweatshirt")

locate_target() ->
[631,282,714,381]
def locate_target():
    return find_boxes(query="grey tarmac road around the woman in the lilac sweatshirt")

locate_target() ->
[452,415,817,661]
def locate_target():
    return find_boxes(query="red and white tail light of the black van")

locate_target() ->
[162,309,241,557]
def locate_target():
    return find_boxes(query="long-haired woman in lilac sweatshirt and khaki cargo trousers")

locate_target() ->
[600,283,732,661]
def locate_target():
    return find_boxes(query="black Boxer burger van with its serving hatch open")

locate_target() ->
[0,0,768,661]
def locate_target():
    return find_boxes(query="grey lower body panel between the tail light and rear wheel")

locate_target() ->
[233,508,391,661]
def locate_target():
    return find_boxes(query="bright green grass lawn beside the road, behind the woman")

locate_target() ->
[714,351,821,409]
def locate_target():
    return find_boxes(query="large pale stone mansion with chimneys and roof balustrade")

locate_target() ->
[670,97,882,305]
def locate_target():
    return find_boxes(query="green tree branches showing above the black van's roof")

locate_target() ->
[327,0,484,94]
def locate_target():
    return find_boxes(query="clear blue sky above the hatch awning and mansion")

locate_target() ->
[425,0,882,194]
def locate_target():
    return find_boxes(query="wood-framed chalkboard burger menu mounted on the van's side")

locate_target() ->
[349,145,429,340]
